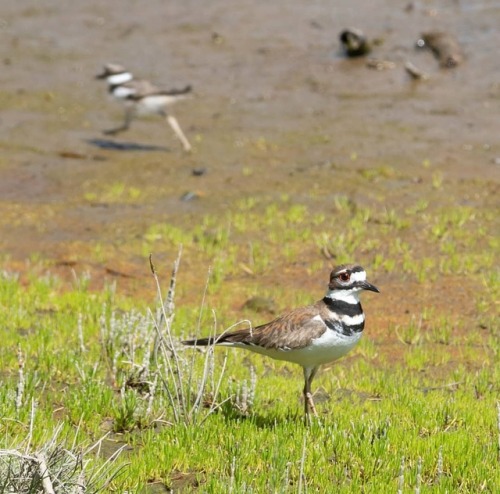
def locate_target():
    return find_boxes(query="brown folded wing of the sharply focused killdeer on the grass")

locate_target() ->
[217,305,326,350]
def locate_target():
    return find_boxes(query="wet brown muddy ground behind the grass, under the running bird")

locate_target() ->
[0,0,500,314]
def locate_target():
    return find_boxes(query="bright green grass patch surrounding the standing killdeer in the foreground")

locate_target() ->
[0,196,500,493]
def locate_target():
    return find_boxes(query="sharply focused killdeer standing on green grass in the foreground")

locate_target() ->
[182,264,379,419]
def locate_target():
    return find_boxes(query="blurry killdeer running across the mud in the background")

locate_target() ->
[96,63,191,151]
